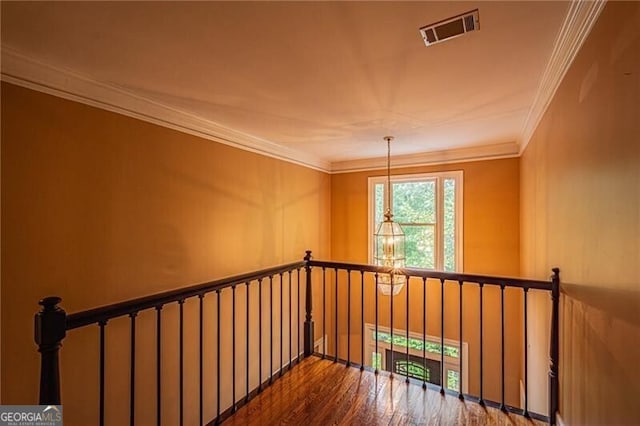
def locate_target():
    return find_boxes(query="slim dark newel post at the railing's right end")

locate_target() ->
[549,268,560,425]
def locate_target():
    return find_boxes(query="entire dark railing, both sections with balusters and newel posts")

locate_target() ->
[35,251,559,425]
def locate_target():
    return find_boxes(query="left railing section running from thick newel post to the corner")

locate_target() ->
[35,261,309,425]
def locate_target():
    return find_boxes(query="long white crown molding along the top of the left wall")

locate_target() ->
[2,50,331,173]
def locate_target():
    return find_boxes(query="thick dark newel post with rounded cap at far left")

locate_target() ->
[34,297,67,405]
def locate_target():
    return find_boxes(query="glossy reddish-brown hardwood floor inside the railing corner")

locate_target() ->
[224,357,545,426]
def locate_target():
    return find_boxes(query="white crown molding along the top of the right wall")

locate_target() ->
[519,0,606,154]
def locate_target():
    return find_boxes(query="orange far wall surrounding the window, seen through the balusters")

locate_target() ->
[328,158,523,405]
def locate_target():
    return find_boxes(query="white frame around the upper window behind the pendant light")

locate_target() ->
[368,170,464,273]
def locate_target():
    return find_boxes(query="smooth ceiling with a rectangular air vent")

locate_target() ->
[2,1,584,169]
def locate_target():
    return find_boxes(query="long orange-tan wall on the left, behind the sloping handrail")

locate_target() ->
[2,83,331,425]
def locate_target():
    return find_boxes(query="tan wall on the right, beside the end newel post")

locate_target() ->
[521,2,640,425]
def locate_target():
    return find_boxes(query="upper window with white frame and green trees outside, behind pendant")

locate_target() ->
[369,171,462,272]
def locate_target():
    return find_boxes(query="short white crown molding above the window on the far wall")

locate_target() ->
[331,142,519,173]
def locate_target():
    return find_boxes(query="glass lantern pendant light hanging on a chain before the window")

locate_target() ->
[374,136,406,296]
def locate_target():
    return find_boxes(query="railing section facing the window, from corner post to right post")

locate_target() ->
[307,260,560,424]
